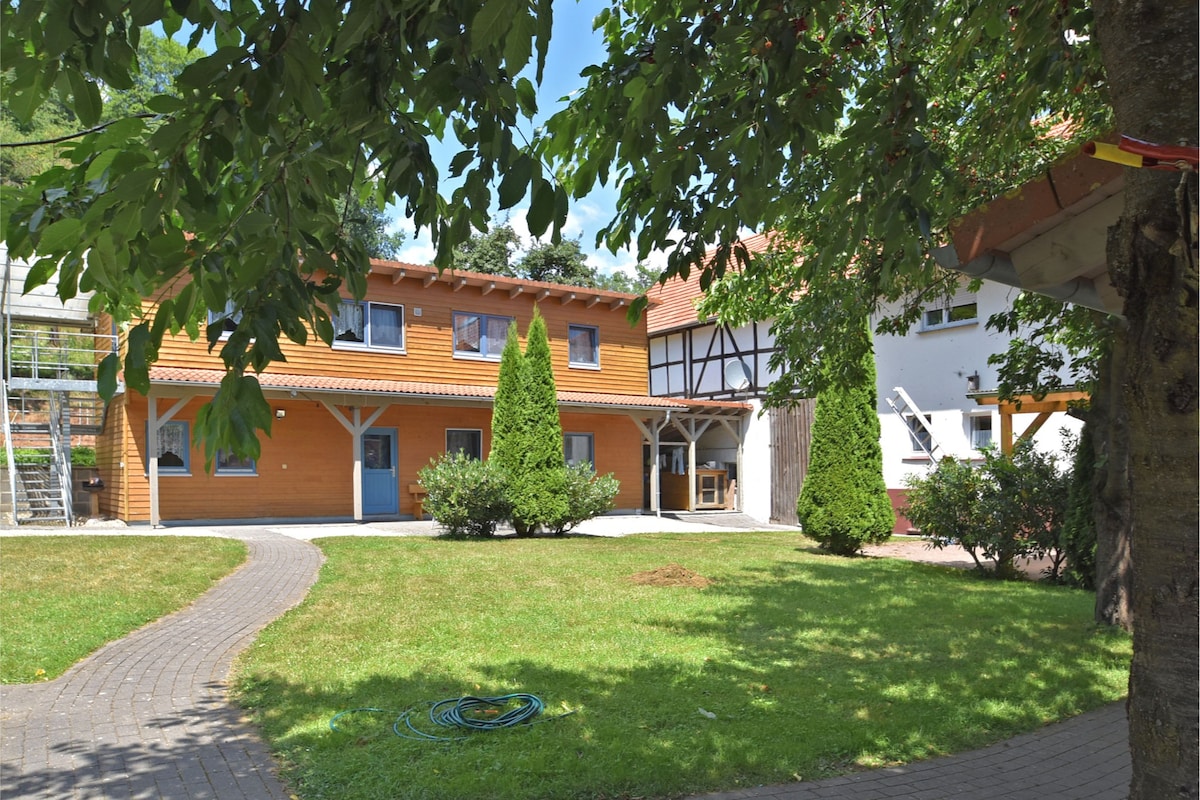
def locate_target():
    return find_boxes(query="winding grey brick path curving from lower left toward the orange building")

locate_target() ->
[0,528,320,800]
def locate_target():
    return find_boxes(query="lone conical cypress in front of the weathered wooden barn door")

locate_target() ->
[797,323,895,555]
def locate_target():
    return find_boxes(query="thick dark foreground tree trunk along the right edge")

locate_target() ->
[1096,0,1200,800]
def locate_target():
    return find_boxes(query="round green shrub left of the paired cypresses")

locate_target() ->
[418,452,511,536]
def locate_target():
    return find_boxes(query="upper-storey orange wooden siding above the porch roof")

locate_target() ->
[157,275,648,395]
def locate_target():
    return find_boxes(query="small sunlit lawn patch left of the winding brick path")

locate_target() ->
[0,536,246,684]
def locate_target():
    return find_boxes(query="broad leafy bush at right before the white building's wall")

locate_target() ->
[904,441,1069,581]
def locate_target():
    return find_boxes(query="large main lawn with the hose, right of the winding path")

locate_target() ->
[238,533,1130,800]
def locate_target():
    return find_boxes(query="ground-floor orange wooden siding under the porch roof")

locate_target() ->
[114,395,642,522]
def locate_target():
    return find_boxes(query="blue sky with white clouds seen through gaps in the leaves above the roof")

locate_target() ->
[394,0,665,278]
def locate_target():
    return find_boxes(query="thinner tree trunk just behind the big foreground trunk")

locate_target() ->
[1087,329,1133,631]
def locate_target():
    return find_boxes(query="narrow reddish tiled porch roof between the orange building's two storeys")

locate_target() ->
[150,367,750,413]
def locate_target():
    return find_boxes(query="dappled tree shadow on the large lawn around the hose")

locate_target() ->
[241,542,1128,800]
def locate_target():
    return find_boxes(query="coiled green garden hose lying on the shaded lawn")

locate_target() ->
[329,692,575,741]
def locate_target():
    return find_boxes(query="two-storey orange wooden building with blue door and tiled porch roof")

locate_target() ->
[97,261,749,524]
